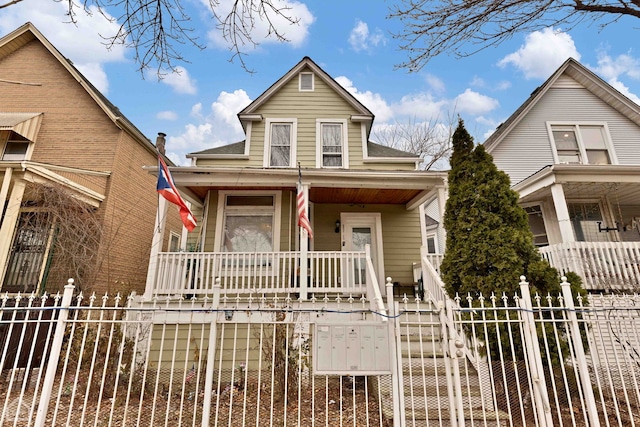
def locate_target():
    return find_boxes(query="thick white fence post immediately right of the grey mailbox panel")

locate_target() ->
[386,277,405,427]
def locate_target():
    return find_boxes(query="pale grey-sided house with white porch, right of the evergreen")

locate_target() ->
[484,59,640,291]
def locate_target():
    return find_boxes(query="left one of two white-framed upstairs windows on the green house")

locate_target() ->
[264,119,296,168]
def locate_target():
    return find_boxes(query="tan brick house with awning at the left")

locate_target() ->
[0,23,181,293]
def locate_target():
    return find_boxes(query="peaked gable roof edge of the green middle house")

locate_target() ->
[238,56,374,121]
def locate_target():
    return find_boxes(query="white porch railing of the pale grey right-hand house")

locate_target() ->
[540,242,640,291]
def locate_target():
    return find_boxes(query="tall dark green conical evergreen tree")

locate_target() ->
[441,119,560,297]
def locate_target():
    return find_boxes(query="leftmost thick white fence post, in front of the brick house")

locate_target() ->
[34,279,75,427]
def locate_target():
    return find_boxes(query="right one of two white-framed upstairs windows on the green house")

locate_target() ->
[316,119,348,168]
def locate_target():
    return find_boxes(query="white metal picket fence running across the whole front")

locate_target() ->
[0,281,640,427]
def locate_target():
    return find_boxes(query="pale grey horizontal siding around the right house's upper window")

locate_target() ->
[491,88,640,184]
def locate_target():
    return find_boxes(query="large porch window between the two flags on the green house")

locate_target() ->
[222,195,275,252]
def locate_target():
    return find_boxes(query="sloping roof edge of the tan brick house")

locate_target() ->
[0,22,156,159]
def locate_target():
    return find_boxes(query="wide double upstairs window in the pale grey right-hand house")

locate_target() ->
[549,124,614,165]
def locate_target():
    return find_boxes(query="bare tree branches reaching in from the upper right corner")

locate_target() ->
[389,0,640,71]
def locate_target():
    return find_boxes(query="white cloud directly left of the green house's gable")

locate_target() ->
[167,89,251,165]
